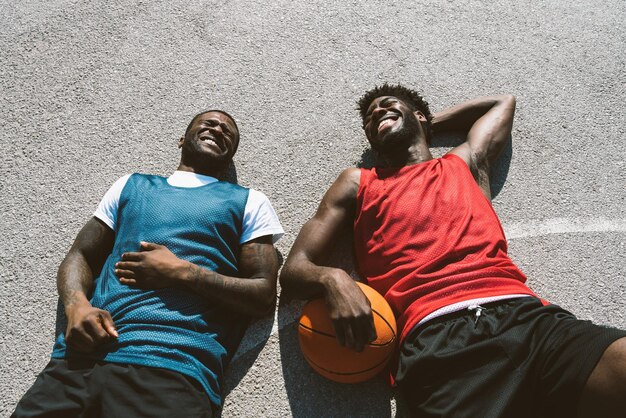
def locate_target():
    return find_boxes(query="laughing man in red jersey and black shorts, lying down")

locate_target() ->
[281,84,626,418]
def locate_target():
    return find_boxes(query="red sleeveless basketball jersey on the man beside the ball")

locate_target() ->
[354,154,534,340]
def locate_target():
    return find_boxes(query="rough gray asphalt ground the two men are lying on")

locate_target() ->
[0,0,626,417]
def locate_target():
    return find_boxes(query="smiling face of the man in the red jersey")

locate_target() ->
[363,96,425,152]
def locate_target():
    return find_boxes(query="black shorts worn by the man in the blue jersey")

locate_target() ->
[11,359,212,418]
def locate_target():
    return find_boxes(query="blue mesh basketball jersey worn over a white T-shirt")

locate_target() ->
[52,174,248,405]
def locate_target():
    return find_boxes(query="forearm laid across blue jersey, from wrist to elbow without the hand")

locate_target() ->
[180,263,276,316]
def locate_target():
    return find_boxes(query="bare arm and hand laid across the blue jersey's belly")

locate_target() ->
[115,235,278,316]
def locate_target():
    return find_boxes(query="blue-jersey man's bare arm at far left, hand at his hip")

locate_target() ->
[57,218,117,351]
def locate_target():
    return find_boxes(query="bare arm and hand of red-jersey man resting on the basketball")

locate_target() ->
[280,169,376,351]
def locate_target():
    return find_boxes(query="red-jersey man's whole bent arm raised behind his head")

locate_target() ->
[433,94,515,199]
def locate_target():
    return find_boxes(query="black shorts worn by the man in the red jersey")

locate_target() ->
[396,297,626,418]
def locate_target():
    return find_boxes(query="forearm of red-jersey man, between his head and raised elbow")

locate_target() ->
[433,94,515,133]
